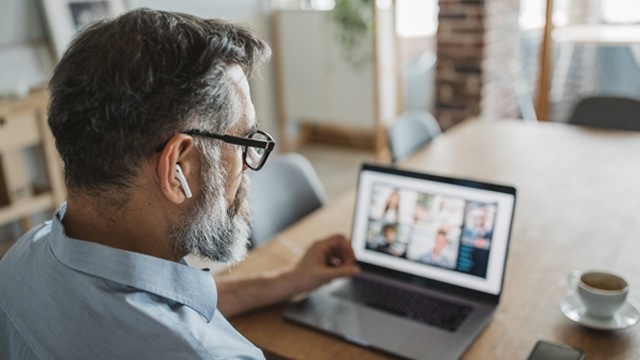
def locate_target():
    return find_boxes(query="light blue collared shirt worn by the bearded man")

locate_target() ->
[0,205,264,360]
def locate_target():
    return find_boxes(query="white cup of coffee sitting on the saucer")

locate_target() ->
[569,271,629,318]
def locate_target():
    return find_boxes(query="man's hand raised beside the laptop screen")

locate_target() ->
[292,235,360,291]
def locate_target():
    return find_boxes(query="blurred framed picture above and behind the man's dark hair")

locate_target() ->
[40,0,127,59]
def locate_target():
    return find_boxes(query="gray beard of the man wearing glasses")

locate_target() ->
[173,160,251,264]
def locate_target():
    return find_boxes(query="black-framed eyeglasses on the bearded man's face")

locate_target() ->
[183,129,276,171]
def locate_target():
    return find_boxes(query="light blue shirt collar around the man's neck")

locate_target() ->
[51,204,217,322]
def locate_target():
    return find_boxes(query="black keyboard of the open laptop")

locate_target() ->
[333,278,473,332]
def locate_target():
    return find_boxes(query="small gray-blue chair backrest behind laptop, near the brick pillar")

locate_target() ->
[388,110,442,162]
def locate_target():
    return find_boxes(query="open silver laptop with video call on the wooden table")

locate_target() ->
[284,164,516,360]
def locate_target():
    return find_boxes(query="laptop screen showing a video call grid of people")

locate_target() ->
[351,164,515,295]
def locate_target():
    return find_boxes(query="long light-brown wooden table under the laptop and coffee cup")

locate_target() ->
[224,120,640,360]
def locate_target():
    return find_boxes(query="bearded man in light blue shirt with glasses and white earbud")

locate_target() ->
[0,9,358,359]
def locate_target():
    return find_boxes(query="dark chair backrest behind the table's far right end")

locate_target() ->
[569,96,640,131]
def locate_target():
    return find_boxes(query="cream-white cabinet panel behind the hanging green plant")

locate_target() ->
[276,10,375,129]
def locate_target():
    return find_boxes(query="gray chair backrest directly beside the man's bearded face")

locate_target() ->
[248,153,327,247]
